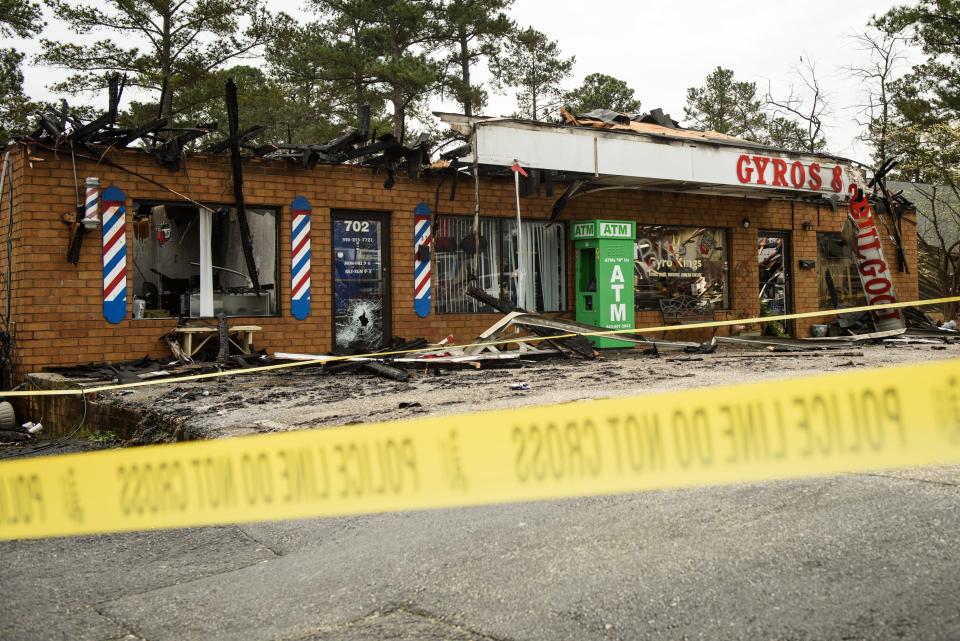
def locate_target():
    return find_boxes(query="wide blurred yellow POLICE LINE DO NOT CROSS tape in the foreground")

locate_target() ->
[0,360,960,539]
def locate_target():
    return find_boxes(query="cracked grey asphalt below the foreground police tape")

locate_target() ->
[0,467,960,641]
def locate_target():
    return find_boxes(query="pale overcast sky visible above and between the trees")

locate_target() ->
[15,0,916,160]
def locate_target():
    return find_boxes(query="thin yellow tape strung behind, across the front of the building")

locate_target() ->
[0,296,960,398]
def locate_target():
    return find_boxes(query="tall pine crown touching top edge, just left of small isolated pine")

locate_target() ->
[438,0,516,116]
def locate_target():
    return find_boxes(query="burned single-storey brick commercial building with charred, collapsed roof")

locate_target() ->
[0,101,917,374]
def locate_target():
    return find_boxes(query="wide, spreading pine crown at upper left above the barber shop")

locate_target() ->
[38,0,283,123]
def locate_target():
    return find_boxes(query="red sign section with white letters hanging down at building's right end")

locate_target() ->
[843,185,904,331]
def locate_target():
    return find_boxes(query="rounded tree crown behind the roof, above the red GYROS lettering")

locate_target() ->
[683,67,767,142]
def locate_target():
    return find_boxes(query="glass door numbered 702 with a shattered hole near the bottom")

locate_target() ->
[331,211,390,354]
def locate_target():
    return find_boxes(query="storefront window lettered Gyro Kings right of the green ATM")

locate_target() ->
[634,225,730,309]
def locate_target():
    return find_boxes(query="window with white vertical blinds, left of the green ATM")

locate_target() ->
[434,216,567,314]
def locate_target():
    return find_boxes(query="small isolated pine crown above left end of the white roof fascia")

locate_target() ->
[495,27,576,120]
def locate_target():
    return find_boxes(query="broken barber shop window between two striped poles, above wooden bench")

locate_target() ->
[133,203,278,318]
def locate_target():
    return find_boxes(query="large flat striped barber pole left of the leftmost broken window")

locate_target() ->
[101,187,127,323]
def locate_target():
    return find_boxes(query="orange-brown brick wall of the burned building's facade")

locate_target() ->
[0,148,917,372]
